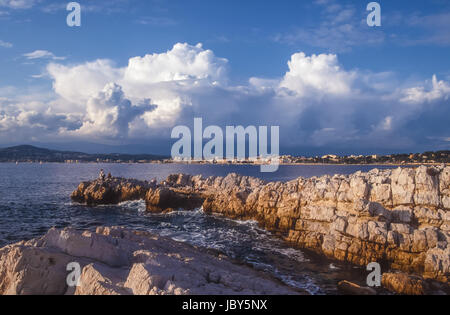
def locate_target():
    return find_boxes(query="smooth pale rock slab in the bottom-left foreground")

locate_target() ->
[0,227,305,295]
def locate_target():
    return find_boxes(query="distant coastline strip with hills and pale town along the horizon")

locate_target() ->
[0,145,450,165]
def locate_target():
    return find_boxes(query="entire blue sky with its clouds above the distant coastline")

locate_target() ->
[0,0,450,155]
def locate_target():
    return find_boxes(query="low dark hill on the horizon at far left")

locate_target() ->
[0,145,167,162]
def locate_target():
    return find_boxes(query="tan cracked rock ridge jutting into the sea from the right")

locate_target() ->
[72,165,450,292]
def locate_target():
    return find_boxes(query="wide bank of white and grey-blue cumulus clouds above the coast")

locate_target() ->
[0,43,450,154]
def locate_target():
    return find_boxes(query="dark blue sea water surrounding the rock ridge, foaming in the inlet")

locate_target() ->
[0,163,400,294]
